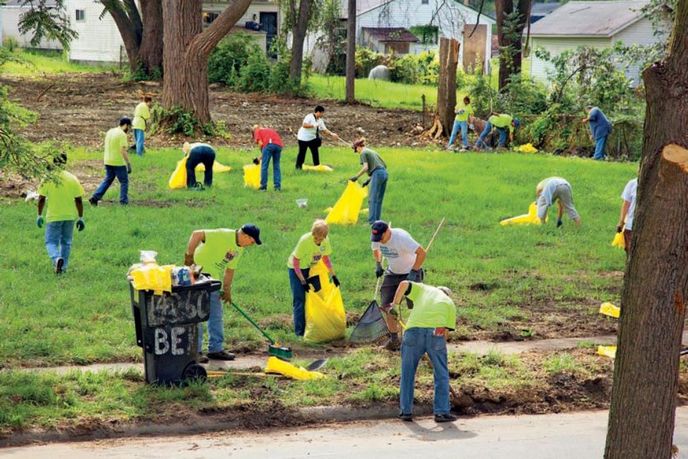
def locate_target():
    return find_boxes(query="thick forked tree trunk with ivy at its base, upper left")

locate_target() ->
[162,0,251,124]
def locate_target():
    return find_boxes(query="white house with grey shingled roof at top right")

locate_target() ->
[530,0,669,83]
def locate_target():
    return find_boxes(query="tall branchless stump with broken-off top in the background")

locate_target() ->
[437,38,459,136]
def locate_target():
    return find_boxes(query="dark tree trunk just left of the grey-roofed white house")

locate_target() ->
[495,0,532,90]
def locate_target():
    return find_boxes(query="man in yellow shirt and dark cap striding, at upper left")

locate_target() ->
[88,117,131,206]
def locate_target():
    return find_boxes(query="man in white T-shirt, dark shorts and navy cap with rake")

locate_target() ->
[370,220,425,351]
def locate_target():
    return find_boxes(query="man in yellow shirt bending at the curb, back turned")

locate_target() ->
[391,281,456,422]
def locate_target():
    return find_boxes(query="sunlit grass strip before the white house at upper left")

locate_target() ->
[0,48,115,77]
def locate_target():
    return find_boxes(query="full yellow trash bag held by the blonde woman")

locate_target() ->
[303,261,346,343]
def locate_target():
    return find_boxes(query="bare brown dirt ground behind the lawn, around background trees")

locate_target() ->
[0,73,436,152]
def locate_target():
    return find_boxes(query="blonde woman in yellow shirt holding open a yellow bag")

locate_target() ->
[287,220,339,336]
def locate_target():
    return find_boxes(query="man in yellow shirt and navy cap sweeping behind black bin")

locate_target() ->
[184,224,262,363]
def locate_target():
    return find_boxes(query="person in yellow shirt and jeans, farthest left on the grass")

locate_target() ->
[36,153,86,274]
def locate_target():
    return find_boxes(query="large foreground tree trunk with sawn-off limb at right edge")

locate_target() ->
[605,0,688,459]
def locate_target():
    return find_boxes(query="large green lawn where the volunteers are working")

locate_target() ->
[0,148,636,367]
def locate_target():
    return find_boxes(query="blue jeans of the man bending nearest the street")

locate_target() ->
[399,328,449,414]
